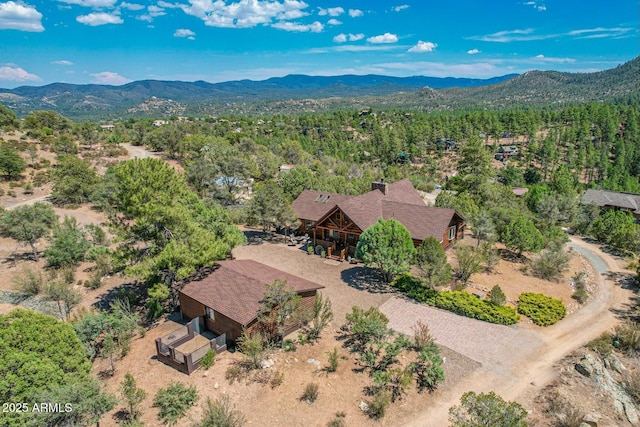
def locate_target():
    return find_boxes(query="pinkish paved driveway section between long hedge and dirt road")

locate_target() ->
[380,297,542,369]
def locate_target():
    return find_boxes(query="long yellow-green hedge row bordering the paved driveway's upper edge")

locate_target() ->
[392,274,520,325]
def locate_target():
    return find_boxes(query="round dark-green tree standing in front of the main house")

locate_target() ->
[355,218,416,283]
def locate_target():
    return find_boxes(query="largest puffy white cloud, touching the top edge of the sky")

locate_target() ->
[174,0,312,31]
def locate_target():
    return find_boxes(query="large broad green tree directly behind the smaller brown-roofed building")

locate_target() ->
[104,158,244,282]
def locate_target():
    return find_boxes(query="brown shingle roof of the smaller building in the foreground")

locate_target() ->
[180,260,324,326]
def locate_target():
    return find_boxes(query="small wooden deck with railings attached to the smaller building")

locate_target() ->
[156,318,227,375]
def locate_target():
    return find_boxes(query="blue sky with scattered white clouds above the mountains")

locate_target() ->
[0,0,640,88]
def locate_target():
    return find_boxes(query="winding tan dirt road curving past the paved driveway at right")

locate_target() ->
[405,237,633,427]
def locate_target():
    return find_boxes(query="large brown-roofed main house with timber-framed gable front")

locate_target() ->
[292,179,464,255]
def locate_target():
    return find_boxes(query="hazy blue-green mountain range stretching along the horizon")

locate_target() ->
[0,57,640,120]
